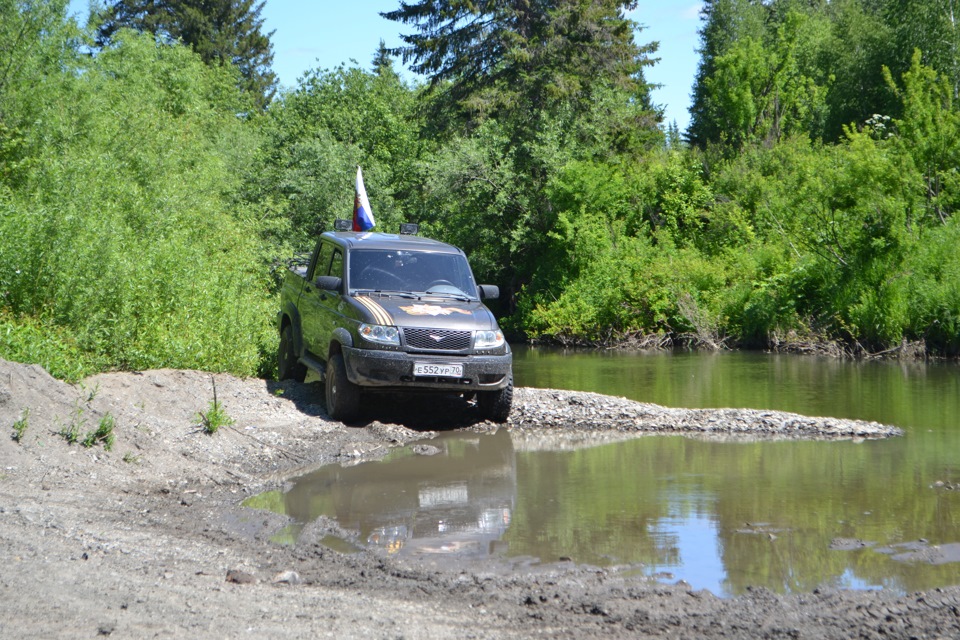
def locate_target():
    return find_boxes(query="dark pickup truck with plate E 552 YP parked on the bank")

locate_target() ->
[278,222,513,422]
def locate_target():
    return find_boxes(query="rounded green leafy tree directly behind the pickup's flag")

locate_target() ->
[258,66,422,246]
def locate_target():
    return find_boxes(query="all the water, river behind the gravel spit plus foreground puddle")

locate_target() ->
[251,349,960,596]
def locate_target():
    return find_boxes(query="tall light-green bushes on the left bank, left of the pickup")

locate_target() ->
[0,14,272,377]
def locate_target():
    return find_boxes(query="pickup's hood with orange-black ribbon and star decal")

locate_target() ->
[354,296,497,331]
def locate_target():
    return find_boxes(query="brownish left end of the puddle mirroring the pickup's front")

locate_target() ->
[284,430,516,555]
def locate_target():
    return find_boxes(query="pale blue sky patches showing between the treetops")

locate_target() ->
[70,0,703,131]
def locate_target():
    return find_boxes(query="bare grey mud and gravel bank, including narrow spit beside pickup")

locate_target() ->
[0,361,960,638]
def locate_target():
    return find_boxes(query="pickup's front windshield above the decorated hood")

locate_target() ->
[348,249,478,298]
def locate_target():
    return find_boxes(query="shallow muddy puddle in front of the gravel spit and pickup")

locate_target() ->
[245,430,960,596]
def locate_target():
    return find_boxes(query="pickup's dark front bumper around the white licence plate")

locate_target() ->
[343,347,513,391]
